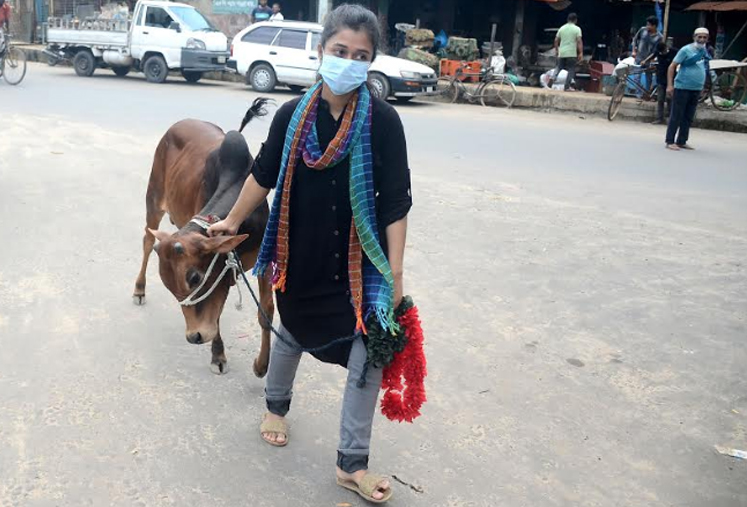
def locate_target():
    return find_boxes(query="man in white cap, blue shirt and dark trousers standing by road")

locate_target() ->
[666,27,710,151]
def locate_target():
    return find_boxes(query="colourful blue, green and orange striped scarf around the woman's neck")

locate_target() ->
[253,81,399,333]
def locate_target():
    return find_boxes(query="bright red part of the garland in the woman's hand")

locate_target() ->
[381,306,428,422]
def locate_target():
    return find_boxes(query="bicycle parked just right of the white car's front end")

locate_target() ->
[436,65,516,107]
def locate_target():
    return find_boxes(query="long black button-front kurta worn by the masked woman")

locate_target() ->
[252,98,412,366]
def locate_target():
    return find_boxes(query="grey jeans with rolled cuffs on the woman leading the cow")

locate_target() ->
[265,325,382,473]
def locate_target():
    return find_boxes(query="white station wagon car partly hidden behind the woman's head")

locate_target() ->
[227,21,438,102]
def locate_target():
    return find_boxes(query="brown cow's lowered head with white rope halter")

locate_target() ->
[148,229,248,343]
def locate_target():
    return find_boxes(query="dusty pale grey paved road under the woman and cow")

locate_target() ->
[0,65,747,507]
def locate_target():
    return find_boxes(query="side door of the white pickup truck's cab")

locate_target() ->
[132,5,182,68]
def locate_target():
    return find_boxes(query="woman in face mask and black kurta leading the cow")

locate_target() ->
[209,5,412,503]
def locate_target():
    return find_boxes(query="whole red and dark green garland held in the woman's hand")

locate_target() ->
[368,296,428,422]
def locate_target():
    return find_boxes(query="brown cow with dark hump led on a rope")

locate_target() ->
[133,99,275,377]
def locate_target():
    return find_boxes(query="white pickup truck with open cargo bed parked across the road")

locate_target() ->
[45,0,230,83]
